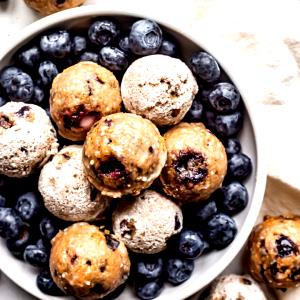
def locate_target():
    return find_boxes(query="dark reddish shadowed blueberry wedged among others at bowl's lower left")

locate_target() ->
[6,226,31,259]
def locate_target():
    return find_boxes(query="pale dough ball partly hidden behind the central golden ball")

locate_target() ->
[39,145,109,221]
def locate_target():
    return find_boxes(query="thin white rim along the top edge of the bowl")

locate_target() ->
[0,1,267,300]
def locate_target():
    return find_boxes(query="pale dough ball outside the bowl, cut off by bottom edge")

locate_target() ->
[206,274,267,300]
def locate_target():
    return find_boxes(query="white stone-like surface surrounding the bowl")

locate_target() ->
[0,0,300,300]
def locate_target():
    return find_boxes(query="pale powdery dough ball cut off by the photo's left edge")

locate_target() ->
[0,102,58,177]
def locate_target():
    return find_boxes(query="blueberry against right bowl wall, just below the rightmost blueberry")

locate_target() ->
[218,182,248,216]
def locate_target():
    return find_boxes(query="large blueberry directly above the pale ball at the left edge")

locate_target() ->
[6,72,33,102]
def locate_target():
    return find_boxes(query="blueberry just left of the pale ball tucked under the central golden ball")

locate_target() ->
[15,192,41,222]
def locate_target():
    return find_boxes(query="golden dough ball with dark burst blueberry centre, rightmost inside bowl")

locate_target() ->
[160,123,227,203]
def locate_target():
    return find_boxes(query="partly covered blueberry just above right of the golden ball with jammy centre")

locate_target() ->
[215,111,243,137]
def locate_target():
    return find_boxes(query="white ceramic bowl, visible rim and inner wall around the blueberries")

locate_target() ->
[0,4,266,300]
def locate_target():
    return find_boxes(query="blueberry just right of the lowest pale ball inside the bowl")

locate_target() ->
[178,230,204,259]
